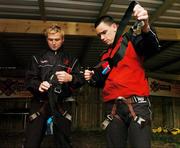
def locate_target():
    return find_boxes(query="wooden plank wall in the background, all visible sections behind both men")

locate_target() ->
[0,85,180,131]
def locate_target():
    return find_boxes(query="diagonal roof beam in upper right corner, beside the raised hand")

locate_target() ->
[150,0,179,24]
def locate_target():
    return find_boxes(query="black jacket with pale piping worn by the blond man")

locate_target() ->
[26,49,84,100]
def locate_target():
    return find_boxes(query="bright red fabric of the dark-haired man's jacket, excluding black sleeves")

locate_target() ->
[101,38,149,102]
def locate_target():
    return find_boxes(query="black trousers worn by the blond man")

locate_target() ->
[24,99,72,148]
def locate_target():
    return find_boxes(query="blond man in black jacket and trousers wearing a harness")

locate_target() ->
[24,25,84,148]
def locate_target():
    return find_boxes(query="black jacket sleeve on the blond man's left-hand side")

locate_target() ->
[25,56,41,94]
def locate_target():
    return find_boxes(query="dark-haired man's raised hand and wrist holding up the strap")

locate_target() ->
[133,4,150,32]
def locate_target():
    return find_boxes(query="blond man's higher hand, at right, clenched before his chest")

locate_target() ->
[56,71,73,84]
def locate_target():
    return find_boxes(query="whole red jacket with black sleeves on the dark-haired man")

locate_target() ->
[92,31,159,102]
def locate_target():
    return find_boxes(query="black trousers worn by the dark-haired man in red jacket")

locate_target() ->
[105,98,151,148]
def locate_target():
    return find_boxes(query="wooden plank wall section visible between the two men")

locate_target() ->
[73,85,104,130]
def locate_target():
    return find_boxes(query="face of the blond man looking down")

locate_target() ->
[47,32,64,51]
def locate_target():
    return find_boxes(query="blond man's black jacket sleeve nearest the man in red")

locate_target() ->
[70,59,85,89]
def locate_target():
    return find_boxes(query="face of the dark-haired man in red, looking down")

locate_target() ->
[96,22,117,45]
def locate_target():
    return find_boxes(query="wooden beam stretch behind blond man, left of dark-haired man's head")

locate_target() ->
[0,19,96,36]
